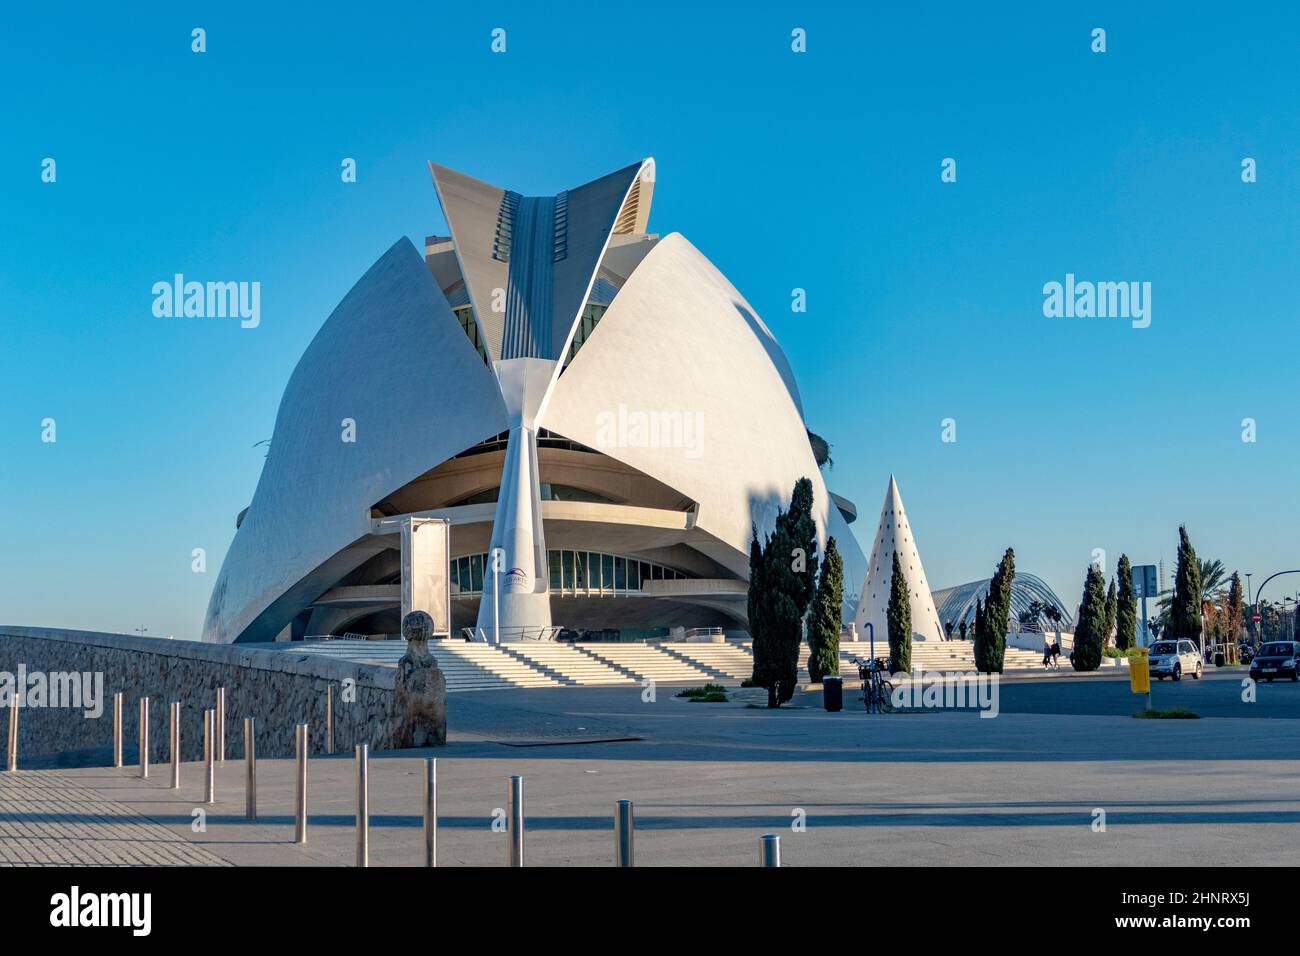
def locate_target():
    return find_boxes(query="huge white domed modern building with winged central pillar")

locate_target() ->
[204,159,868,643]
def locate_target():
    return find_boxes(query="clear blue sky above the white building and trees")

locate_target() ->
[0,3,1300,637]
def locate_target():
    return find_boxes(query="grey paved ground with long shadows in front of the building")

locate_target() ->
[0,672,1300,866]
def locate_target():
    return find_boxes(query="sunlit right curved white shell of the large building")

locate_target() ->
[541,233,863,580]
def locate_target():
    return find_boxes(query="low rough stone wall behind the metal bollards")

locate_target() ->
[0,626,398,767]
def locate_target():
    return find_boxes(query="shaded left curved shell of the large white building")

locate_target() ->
[203,238,506,643]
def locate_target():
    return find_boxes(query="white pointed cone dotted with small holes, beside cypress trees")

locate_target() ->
[855,475,944,656]
